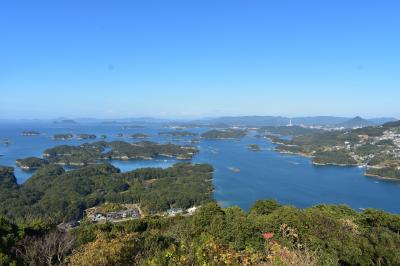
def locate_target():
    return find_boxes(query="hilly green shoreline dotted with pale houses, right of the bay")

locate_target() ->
[267,122,400,180]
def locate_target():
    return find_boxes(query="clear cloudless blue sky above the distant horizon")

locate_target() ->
[0,0,400,118]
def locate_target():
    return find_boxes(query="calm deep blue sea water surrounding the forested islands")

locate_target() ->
[0,125,400,213]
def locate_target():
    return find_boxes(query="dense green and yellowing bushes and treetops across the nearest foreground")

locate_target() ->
[0,201,400,265]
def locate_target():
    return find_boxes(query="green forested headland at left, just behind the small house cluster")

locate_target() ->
[0,163,213,224]
